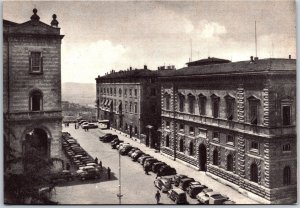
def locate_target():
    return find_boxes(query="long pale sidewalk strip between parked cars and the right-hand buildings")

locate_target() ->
[101,126,259,204]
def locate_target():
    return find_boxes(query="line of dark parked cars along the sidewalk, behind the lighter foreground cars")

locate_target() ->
[99,133,176,176]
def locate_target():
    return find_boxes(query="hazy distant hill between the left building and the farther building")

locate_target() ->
[62,82,96,107]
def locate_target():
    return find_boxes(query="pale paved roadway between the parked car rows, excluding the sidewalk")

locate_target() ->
[53,125,186,204]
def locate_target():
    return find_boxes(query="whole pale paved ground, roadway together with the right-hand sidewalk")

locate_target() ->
[54,125,257,204]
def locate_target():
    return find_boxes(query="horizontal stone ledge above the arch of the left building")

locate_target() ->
[4,111,62,121]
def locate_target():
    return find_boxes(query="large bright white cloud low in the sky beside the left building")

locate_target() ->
[62,40,129,83]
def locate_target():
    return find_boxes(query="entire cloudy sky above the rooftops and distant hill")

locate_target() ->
[3,1,296,83]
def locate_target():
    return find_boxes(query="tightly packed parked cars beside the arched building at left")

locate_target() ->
[62,132,101,180]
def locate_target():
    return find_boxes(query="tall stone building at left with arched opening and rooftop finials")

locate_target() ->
[3,9,63,174]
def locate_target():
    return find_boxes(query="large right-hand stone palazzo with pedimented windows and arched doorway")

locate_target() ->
[159,58,297,203]
